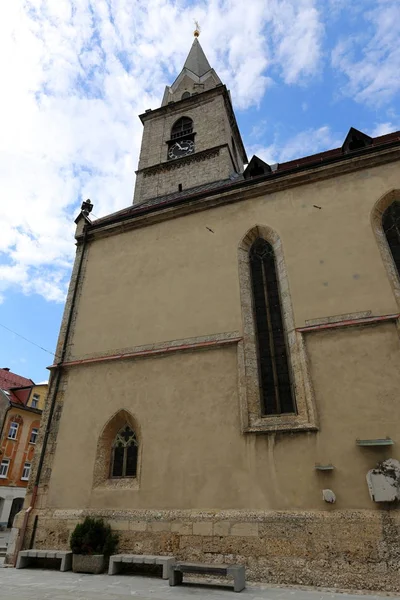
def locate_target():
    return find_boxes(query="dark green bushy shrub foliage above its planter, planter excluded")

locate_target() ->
[70,517,119,556]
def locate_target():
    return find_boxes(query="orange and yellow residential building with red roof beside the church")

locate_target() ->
[0,369,47,528]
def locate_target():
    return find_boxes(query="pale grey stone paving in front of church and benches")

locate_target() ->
[0,563,399,600]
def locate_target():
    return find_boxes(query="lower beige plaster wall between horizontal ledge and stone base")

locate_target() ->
[48,324,400,510]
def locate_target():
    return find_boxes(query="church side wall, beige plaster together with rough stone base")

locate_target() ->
[7,158,400,591]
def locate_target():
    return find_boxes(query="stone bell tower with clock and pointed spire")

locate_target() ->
[134,30,248,204]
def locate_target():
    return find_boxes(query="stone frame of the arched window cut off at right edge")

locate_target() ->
[371,189,400,306]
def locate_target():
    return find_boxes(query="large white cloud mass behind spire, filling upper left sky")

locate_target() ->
[0,0,323,301]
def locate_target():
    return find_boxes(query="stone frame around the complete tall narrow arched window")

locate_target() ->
[238,225,318,433]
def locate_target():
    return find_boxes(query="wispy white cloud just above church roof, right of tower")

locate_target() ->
[249,125,343,165]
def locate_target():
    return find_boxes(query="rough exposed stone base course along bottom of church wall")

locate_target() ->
[6,509,400,592]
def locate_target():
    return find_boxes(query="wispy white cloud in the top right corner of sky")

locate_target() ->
[332,0,400,106]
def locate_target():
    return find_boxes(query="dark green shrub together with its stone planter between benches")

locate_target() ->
[70,517,118,573]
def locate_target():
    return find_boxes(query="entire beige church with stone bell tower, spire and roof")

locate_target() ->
[7,32,400,592]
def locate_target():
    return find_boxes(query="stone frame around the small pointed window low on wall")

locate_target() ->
[92,408,143,490]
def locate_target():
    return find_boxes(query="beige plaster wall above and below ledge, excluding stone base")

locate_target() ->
[43,158,400,510]
